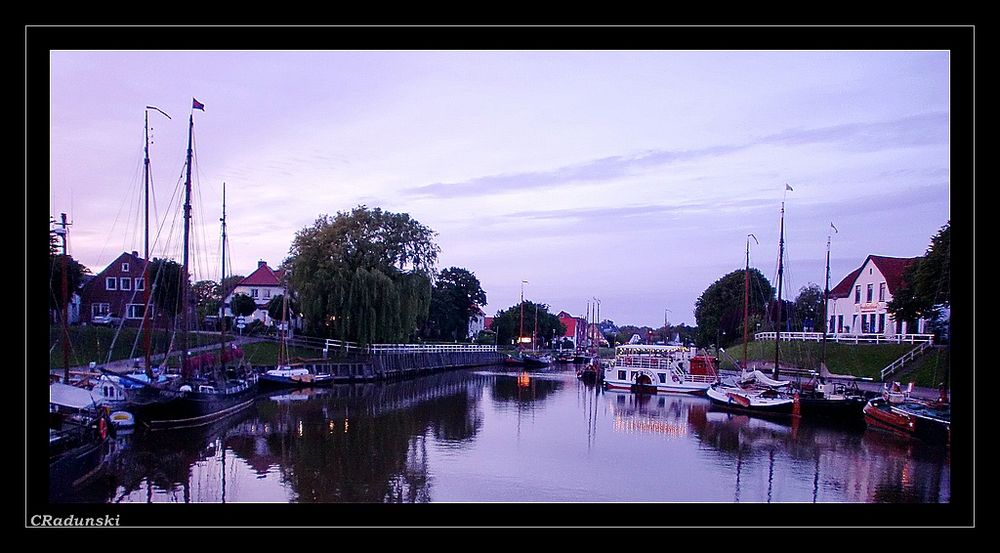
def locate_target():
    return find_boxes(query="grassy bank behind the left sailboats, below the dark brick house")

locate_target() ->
[49,326,230,369]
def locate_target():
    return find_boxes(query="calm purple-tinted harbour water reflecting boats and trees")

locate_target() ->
[54,368,951,503]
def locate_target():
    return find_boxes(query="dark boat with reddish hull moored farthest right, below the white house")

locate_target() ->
[863,382,951,444]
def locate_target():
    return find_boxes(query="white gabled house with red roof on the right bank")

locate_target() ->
[827,255,927,336]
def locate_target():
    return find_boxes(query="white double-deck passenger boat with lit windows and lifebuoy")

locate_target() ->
[604,344,718,393]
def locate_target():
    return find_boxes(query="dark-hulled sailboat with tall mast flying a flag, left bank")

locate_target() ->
[110,100,257,427]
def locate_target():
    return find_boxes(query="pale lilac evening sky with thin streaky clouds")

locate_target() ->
[49,50,950,327]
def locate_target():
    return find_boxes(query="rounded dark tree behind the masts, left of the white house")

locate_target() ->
[694,269,775,346]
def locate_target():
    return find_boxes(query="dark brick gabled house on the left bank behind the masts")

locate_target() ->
[78,251,157,325]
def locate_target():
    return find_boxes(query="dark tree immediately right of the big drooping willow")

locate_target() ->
[427,267,486,340]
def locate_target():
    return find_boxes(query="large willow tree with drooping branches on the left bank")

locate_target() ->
[285,205,440,344]
